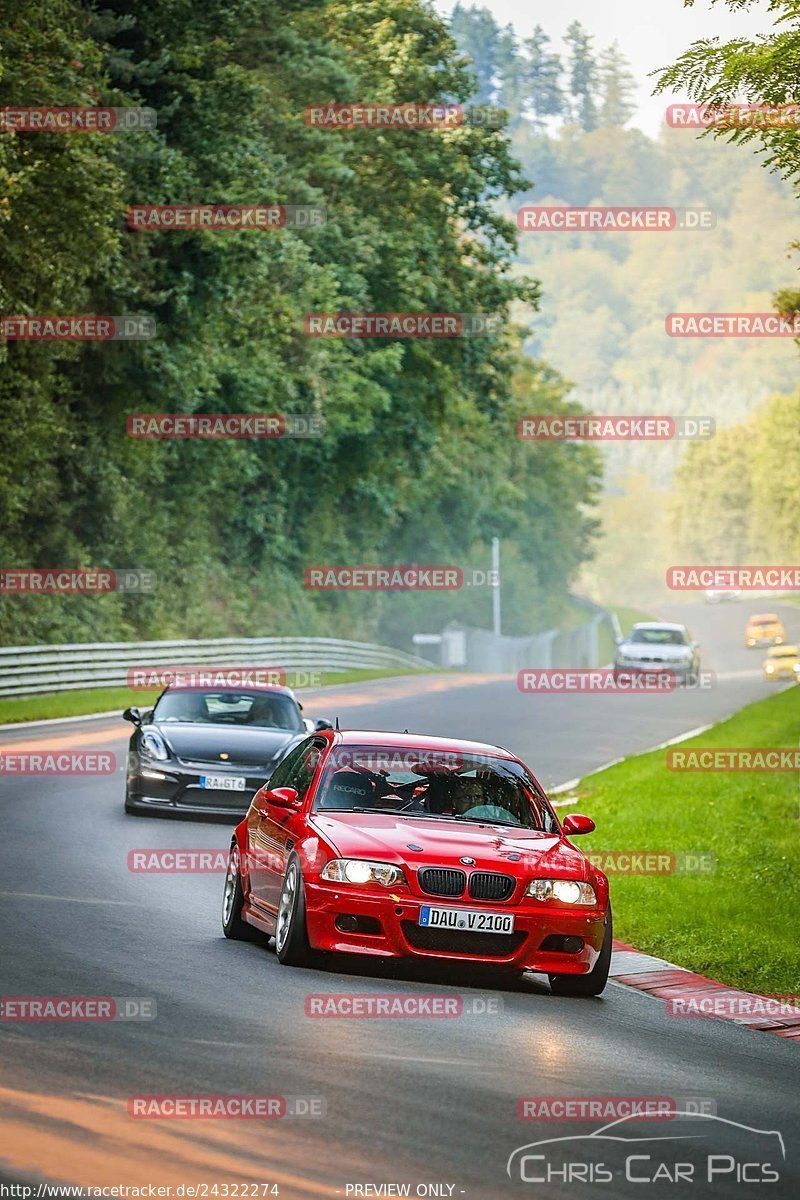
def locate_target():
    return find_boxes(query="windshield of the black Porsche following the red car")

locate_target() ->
[152,688,302,731]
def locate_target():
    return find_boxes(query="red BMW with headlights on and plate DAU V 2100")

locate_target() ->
[222,730,612,996]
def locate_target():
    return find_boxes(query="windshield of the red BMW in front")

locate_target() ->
[314,746,558,833]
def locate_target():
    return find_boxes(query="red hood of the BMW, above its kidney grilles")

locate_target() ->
[312,812,589,880]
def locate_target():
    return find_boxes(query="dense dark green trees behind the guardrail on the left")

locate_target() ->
[0,0,600,648]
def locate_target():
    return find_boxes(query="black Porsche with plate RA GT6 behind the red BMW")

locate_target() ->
[122,685,330,816]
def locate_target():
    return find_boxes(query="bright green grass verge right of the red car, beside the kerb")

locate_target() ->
[559,688,800,995]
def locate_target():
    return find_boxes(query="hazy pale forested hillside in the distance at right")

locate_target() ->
[452,0,800,605]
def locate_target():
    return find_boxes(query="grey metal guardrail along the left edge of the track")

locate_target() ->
[0,637,434,696]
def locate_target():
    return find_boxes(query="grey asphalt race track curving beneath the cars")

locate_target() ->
[0,601,800,1200]
